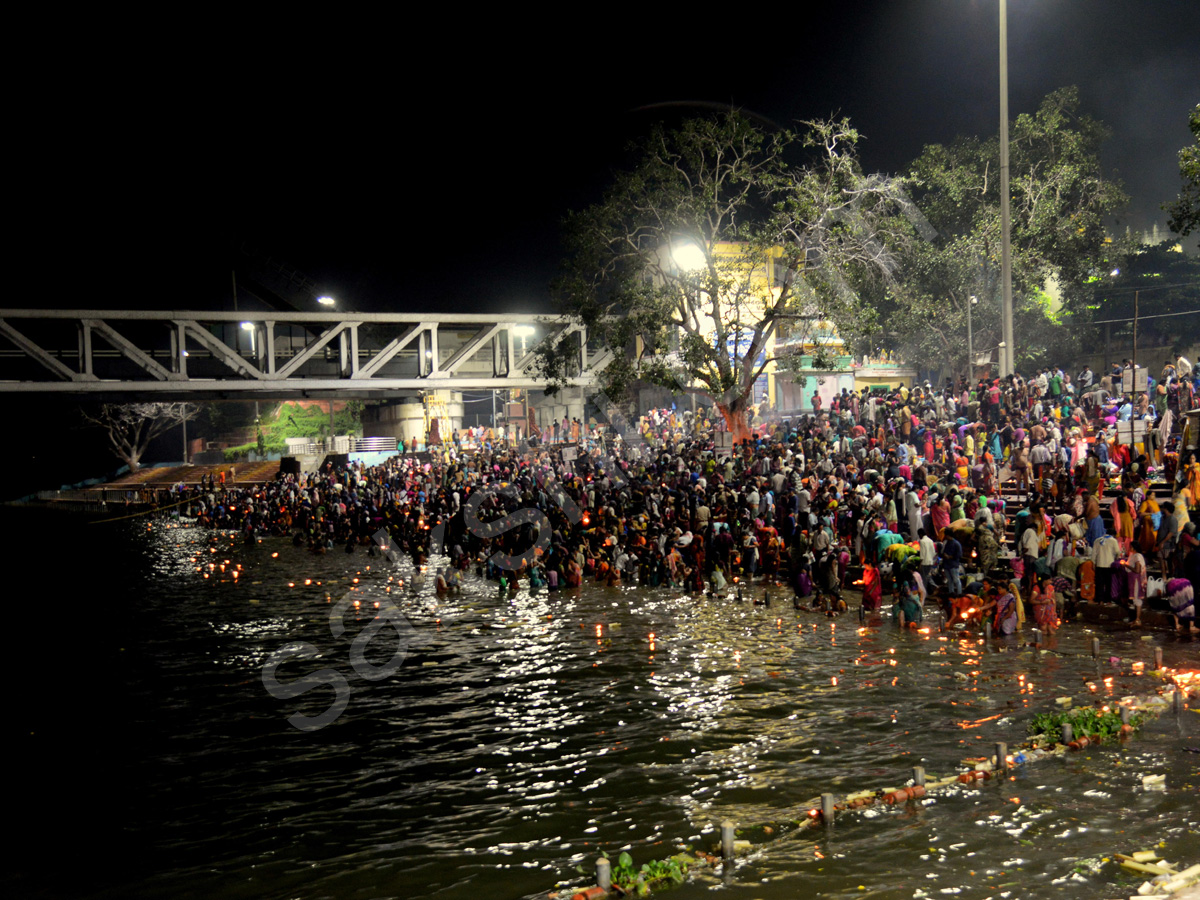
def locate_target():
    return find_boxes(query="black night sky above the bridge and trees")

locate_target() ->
[25,0,1200,312]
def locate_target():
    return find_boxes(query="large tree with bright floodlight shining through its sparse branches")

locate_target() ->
[541,112,902,438]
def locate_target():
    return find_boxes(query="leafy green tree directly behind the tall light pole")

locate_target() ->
[872,88,1127,372]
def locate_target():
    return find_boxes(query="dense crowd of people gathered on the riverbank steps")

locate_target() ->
[171,358,1200,634]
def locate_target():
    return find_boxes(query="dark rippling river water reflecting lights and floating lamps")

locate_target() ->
[0,510,1200,900]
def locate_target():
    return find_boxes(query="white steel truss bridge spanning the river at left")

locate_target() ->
[0,310,612,401]
